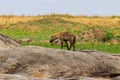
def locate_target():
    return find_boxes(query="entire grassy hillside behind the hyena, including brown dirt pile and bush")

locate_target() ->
[0,14,120,53]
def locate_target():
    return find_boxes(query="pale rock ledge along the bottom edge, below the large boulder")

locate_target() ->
[0,74,110,80]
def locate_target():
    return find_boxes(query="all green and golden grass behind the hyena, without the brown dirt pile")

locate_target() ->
[0,15,120,53]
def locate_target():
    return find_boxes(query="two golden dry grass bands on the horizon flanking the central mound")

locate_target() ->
[0,15,120,28]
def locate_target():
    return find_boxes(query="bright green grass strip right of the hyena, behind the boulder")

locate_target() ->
[76,43,120,54]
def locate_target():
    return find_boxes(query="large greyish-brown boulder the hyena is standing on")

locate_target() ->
[0,46,120,80]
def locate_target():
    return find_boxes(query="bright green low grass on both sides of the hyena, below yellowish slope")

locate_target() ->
[1,30,120,54]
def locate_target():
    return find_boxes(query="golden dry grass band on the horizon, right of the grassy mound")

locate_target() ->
[63,17,120,28]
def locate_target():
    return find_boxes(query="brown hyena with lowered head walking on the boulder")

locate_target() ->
[50,31,76,50]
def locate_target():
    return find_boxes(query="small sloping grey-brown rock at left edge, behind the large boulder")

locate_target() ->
[0,34,20,51]
